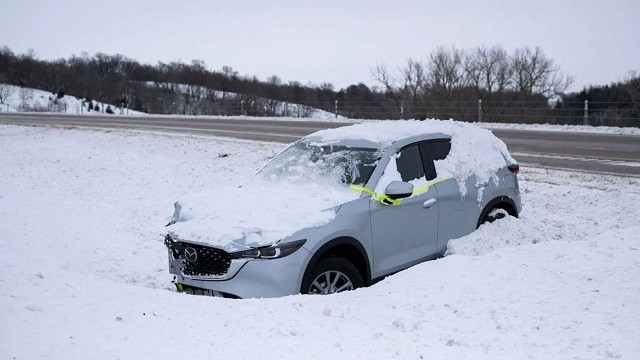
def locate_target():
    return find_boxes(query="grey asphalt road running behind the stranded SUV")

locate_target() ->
[0,113,640,177]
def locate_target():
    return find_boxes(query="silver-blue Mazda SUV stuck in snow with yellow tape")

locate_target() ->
[164,120,521,298]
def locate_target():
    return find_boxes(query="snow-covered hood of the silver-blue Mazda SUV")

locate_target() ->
[164,181,359,252]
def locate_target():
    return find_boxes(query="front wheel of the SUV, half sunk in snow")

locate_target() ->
[301,256,364,295]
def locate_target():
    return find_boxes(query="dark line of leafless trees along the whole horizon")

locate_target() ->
[0,46,640,126]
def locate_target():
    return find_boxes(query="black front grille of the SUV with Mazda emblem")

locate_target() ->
[165,236,234,276]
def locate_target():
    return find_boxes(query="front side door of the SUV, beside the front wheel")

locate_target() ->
[369,144,438,277]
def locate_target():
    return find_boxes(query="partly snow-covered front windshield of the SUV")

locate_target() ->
[256,141,380,185]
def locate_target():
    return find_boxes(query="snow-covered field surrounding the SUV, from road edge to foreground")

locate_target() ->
[0,126,640,359]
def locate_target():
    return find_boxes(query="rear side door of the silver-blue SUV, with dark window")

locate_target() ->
[420,139,478,252]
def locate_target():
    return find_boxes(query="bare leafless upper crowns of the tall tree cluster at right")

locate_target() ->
[373,45,573,101]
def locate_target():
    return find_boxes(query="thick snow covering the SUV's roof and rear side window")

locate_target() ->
[309,119,516,196]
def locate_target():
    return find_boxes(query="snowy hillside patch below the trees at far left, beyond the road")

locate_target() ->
[0,83,146,116]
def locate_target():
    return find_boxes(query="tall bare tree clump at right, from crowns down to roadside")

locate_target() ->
[373,45,573,121]
